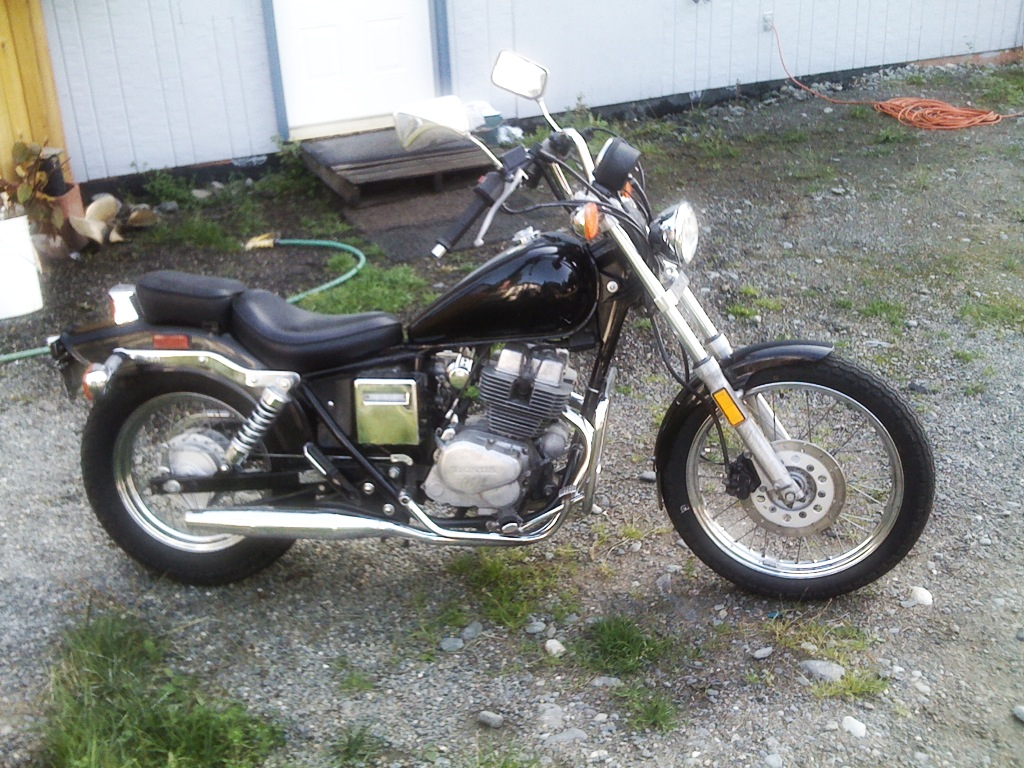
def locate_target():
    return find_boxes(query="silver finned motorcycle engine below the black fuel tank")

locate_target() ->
[424,344,577,519]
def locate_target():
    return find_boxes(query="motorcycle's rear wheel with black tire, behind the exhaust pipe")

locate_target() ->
[82,374,294,585]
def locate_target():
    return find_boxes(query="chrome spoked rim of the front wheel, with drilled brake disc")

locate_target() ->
[686,382,905,580]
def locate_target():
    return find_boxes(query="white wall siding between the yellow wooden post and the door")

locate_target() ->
[42,0,278,181]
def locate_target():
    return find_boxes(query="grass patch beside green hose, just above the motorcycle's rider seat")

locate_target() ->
[299,260,432,314]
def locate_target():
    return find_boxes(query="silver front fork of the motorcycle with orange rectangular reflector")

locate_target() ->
[604,216,797,501]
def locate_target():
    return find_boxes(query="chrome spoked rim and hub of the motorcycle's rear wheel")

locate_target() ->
[114,392,265,554]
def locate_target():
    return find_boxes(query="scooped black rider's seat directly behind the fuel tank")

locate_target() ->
[232,291,402,374]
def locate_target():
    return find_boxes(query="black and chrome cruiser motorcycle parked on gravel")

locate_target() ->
[51,51,935,599]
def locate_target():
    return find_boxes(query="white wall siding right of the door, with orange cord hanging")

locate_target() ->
[449,0,1024,117]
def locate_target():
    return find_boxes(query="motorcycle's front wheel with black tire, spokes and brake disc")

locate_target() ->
[662,356,935,599]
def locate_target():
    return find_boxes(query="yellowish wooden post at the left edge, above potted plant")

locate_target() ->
[0,0,71,181]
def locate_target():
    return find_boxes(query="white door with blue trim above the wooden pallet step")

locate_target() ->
[273,0,436,140]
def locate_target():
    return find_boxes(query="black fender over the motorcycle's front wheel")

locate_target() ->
[654,341,835,493]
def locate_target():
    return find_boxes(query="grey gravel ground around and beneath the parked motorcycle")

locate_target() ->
[0,69,1024,768]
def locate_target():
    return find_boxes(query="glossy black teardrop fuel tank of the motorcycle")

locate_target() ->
[409,233,598,344]
